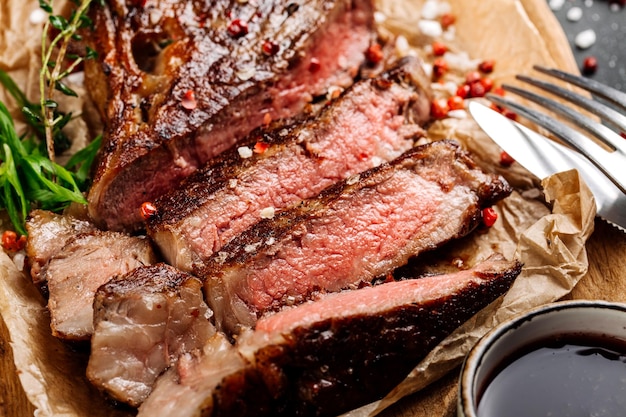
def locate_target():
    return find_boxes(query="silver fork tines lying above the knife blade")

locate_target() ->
[487,66,626,194]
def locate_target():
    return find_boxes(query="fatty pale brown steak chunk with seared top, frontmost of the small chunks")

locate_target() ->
[87,264,215,407]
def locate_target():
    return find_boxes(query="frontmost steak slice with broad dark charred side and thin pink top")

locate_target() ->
[139,255,521,417]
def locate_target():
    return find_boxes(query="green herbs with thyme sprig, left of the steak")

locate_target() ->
[0,0,101,235]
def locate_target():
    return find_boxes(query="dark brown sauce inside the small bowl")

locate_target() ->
[477,334,626,417]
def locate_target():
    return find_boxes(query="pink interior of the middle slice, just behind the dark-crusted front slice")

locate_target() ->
[232,170,461,311]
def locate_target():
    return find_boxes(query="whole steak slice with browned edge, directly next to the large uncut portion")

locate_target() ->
[147,58,430,271]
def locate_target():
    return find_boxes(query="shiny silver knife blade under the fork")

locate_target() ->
[469,102,626,233]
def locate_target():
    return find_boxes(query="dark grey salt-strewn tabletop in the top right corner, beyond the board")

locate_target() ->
[546,0,626,91]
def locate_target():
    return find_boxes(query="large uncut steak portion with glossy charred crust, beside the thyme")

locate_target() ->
[86,0,373,230]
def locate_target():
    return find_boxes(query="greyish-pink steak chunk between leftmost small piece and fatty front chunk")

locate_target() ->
[42,230,157,340]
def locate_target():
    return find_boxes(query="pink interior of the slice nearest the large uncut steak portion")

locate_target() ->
[181,84,413,259]
